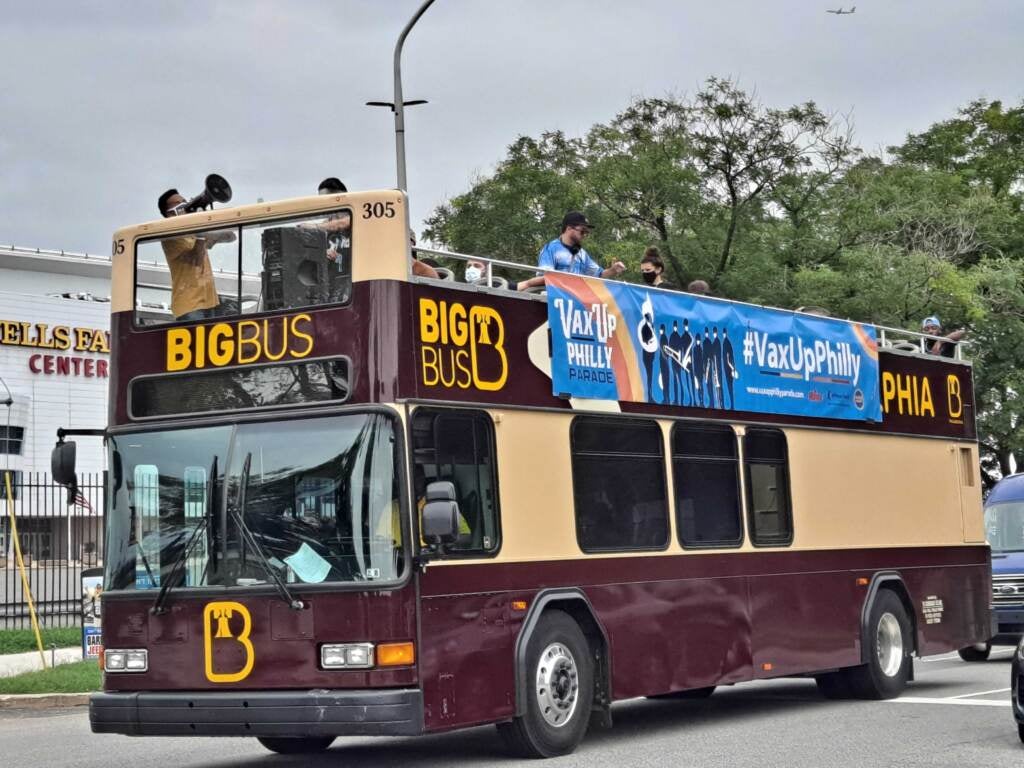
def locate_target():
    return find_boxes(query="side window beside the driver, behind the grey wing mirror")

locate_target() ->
[412,408,501,554]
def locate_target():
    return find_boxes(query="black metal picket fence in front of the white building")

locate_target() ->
[0,471,106,630]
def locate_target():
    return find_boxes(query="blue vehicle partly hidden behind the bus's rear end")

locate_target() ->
[959,473,1024,663]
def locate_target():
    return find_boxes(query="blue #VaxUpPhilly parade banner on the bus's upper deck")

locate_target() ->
[547,273,882,421]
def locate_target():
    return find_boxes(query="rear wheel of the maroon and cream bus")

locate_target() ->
[846,589,913,698]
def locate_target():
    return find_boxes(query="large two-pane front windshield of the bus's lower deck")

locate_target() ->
[105,414,404,592]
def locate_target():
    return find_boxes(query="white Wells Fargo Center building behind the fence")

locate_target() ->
[0,246,169,573]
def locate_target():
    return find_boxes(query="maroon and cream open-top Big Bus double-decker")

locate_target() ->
[55,190,990,757]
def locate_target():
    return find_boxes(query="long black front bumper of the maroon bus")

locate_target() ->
[89,688,423,736]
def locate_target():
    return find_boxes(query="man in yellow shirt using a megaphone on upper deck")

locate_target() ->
[158,189,236,321]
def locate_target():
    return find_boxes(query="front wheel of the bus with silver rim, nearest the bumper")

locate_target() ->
[498,609,594,758]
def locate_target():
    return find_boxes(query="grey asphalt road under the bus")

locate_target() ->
[0,648,1024,768]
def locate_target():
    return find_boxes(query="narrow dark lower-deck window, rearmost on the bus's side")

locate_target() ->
[743,427,793,547]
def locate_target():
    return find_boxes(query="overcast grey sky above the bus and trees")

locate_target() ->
[0,0,1024,254]
